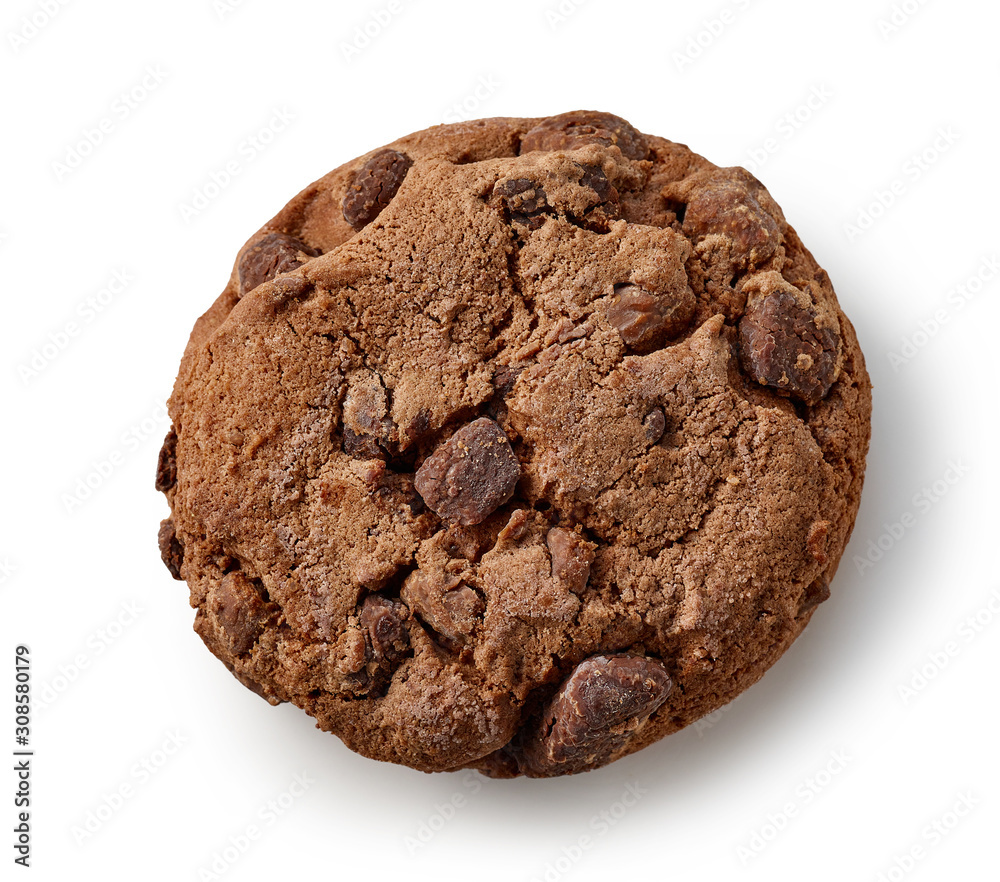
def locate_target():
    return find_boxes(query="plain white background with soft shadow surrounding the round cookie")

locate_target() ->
[0,0,1000,882]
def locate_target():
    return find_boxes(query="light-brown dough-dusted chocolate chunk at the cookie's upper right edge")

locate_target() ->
[682,169,782,268]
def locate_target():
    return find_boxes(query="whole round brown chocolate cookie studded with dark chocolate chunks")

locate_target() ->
[156,111,871,777]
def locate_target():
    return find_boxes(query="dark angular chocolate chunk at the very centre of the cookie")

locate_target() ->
[414,417,521,524]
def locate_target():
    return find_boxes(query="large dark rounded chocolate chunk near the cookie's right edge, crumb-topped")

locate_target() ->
[739,290,840,404]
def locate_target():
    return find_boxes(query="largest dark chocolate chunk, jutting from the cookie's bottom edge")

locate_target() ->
[522,655,673,777]
